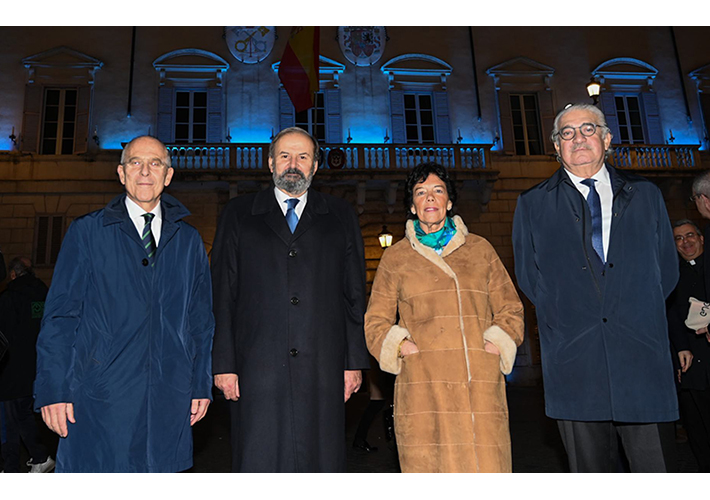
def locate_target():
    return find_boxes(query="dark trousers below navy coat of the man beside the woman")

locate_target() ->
[557,420,677,472]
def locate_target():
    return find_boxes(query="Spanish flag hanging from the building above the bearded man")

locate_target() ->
[279,26,320,113]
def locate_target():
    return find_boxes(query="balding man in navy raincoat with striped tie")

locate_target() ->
[35,136,214,472]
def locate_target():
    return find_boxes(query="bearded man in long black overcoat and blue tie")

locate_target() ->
[212,128,369,472]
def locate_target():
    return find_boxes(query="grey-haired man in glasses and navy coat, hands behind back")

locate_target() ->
[513,104,678,472]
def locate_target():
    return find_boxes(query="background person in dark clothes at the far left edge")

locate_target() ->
[0,257,54,472]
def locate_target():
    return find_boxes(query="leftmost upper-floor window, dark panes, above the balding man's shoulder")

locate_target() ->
[40,88,77,155]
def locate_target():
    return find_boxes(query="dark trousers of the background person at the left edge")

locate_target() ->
[1,396,48,472]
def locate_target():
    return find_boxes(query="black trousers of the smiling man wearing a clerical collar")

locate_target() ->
[678,389,710,472]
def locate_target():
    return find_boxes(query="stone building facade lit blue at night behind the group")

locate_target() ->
[0,26,710,382]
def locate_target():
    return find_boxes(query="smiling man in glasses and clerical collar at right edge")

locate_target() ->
[668,219,710,472]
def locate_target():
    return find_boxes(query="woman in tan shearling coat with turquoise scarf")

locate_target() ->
[365,163,523,472]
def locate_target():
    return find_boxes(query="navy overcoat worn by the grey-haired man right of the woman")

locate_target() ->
[513,166,678,423]
